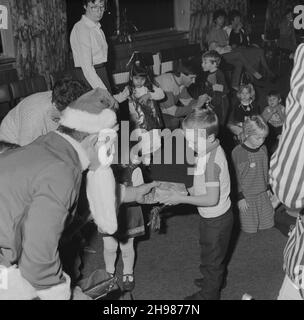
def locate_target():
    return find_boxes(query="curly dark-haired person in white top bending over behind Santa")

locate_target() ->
[0,78,89,146]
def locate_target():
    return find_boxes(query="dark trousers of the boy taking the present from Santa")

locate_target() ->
[199,209,233,300]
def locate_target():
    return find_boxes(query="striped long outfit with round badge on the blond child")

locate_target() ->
[232,145,274,233]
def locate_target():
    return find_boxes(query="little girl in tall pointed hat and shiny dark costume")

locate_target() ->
[114,52,165,131]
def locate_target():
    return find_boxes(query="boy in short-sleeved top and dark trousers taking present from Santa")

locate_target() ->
[160,108,233,300]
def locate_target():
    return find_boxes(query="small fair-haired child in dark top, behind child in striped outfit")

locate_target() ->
[228,84,260,141]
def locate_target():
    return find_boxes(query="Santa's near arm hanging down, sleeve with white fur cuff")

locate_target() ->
[19,164,80,300]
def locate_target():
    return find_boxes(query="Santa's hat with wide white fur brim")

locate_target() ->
[59,88,117,134]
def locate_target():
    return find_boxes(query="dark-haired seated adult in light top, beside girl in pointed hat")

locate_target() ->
[155,59,208,129]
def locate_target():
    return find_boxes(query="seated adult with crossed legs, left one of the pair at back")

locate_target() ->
[207,10,262,90]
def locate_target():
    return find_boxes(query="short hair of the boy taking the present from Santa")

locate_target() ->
[183,108,219,137]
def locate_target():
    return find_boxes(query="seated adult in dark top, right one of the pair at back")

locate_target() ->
[224,10,274,78]
